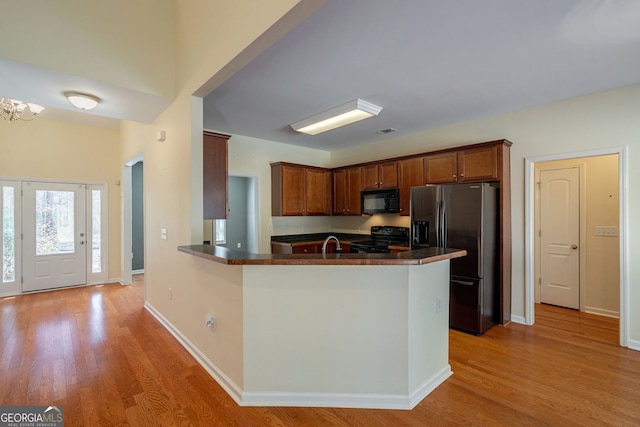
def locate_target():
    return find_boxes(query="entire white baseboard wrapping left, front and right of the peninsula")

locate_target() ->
[144,302,453,409]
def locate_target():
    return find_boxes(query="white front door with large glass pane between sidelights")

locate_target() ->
[22,182,87,292]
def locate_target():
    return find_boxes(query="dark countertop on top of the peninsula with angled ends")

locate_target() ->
[178,246,467,265]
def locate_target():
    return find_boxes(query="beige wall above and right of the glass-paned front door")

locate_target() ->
[0,118,121,280]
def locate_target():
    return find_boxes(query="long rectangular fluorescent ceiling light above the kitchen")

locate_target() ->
[291,99,382,135]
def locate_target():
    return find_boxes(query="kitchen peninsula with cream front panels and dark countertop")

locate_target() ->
[178,245,466,409]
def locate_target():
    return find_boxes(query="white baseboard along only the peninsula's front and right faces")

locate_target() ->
[241,365,453,410]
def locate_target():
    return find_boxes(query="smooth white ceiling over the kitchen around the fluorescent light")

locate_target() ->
[204,0,640,151]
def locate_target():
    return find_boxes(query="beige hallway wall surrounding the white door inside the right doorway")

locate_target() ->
[535,154,620,316]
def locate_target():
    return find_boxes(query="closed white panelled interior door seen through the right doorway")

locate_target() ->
[540,168,580,310]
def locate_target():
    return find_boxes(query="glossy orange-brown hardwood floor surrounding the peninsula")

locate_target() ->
[0,276,640,426]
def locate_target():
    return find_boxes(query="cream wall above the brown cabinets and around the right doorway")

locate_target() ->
[331,85,640,348]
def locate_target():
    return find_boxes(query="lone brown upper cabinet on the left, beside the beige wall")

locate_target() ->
[202,132,231,219]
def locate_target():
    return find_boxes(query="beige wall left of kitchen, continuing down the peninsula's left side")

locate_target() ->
[120,0,316,387]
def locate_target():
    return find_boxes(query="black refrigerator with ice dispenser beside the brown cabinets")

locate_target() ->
[410,183,499,335]
